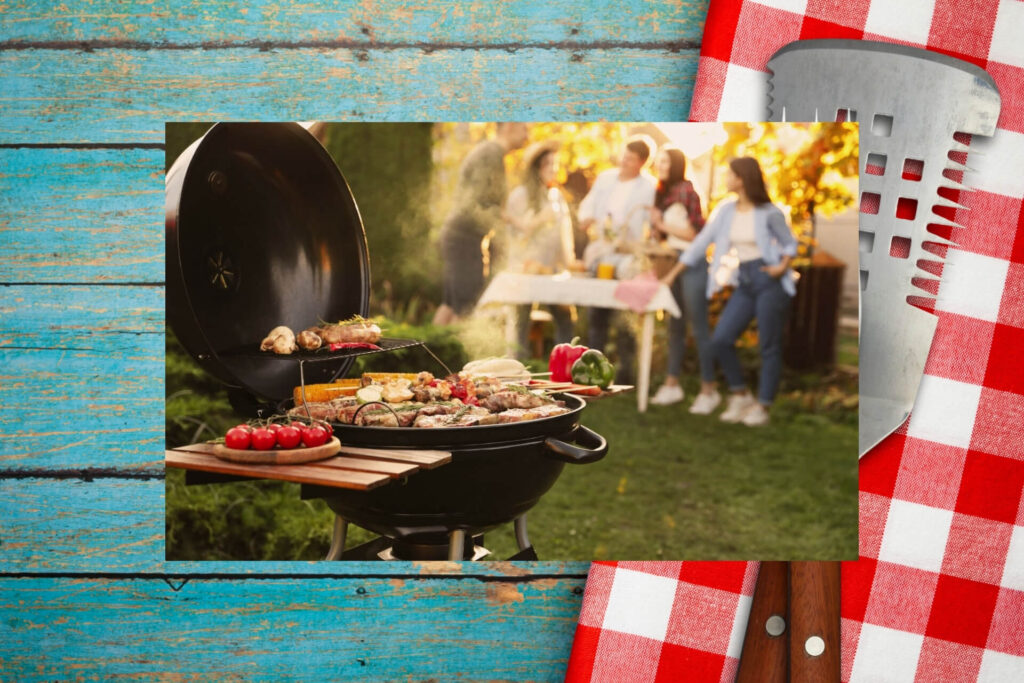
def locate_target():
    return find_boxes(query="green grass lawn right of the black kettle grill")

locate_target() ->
[503,396,857,560]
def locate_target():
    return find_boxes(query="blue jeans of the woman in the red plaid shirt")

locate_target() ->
[669,261,715,382]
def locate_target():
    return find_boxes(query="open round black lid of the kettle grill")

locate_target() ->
[165,123,370,400]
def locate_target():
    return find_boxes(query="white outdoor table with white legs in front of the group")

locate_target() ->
[478,271,682,413]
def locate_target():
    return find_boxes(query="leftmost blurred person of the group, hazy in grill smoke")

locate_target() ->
[433,122,529,325]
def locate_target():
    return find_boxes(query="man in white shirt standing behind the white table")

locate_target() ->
[579,137,655,384]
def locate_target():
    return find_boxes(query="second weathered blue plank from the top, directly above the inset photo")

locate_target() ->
[0,48,696,143]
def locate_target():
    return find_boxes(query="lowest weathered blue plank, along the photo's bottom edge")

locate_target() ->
[0,578,582,682]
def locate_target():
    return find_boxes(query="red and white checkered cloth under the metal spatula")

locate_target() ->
[566,0,1024,683]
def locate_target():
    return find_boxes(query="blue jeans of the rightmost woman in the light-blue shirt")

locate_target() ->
[711,259,790,405]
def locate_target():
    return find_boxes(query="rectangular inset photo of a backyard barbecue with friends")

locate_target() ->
[165,122,859,570]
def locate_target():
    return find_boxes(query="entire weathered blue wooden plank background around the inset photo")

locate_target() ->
[0,0,707,681]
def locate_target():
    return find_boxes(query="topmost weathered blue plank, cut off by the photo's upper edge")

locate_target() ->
[2,0,708,44]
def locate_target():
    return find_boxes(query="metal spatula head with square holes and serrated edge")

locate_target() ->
[768,40,999,456]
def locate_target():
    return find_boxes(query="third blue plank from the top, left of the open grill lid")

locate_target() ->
[0,148,164,282]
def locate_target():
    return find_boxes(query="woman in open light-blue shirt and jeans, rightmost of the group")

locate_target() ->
[663,157,797,427]
